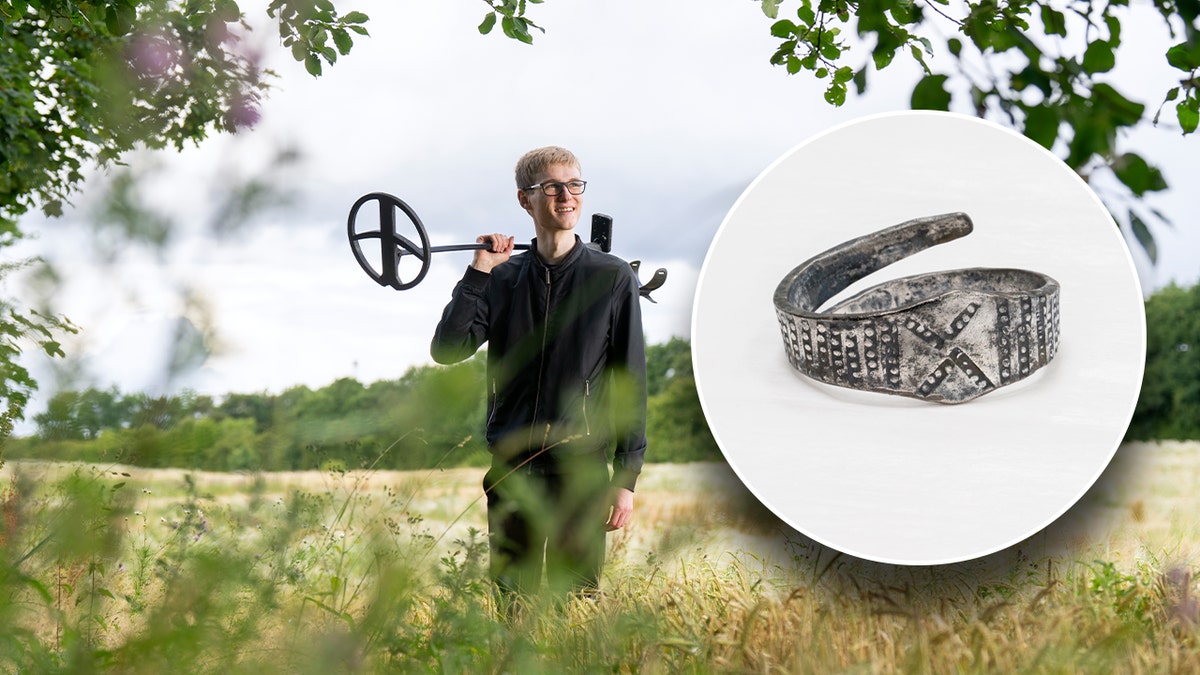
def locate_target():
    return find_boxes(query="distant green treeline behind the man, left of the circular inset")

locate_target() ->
[7,339,720,471]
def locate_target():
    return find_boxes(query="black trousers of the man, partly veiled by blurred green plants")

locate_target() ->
[484,458,608,601]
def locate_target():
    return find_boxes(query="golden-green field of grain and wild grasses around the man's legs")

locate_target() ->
[0,443,1200,674]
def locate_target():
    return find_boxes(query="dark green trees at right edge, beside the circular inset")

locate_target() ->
[1127,283,1200,440]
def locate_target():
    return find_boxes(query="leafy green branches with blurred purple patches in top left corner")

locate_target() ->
[0,0,367,230]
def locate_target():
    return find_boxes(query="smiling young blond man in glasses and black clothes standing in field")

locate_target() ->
[431,147,646,601]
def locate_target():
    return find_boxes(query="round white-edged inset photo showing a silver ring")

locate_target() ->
[692,112,1146,565]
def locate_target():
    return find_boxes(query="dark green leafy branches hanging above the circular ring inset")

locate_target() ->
[761,0,1200,261]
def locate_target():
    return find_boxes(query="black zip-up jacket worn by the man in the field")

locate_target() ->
[430,237,646,490]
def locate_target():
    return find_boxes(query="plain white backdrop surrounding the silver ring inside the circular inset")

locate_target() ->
[691,112,1146,565]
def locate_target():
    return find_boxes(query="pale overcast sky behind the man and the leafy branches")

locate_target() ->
[10,0,1200,427]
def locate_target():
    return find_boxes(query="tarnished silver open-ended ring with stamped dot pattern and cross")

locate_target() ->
[775,213,1058,404]
